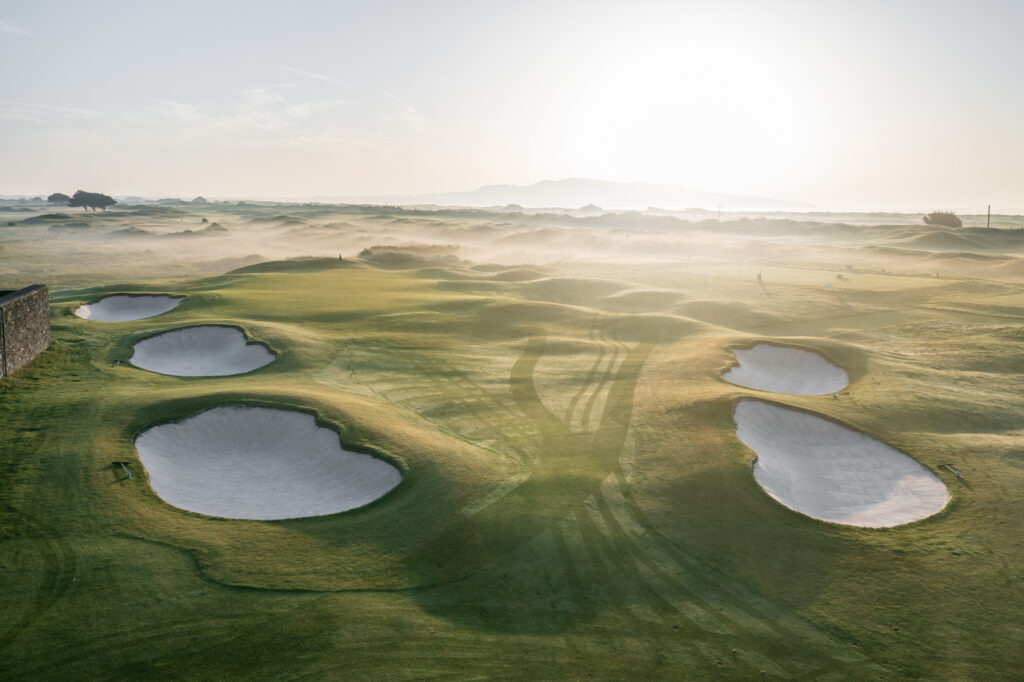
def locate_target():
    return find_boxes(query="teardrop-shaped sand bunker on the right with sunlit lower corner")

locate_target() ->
[733,398,949,528]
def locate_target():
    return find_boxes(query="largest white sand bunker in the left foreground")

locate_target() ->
[135,406,401,520]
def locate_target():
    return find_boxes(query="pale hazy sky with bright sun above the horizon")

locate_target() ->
[0,0,1024,206]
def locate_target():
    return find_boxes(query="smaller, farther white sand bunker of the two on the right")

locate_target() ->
[722,343,850,395]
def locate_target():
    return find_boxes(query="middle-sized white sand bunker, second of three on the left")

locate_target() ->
[130,325,273,377]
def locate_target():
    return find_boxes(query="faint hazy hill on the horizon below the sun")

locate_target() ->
[342,178,811,209]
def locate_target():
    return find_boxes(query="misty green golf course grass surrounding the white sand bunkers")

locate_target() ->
[0,204,1024,680]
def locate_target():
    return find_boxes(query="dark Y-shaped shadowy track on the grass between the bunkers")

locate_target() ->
[407,337,654,632]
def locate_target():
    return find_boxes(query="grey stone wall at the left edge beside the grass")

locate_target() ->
[0,285,50,377]
